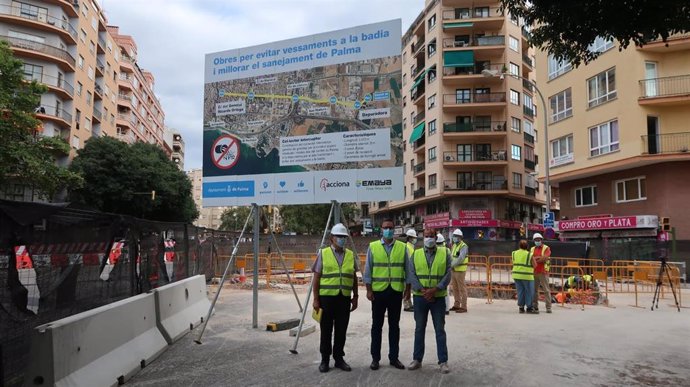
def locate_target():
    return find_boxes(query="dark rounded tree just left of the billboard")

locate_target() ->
[70,137,199,222]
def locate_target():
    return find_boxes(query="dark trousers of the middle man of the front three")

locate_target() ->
[371,286,402,361]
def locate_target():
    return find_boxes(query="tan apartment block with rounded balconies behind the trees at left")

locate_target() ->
[0,0,164,200]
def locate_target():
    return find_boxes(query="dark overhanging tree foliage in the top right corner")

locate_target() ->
[501,0,690,66]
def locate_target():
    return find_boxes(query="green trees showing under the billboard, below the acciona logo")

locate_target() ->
[280,204,357,235]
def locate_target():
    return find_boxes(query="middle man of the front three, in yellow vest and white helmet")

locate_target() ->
[362,219,410,370]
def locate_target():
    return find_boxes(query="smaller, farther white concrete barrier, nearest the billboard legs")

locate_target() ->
[154,275,211,344]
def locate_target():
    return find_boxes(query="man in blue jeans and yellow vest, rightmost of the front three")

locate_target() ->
[407,228,450,374]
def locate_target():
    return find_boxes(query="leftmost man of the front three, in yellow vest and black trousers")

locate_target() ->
[312,223,359,372]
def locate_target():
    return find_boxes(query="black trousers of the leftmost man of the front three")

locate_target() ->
[319,294,350,361]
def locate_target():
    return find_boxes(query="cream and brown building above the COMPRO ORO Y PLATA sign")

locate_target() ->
[536,34,690,239]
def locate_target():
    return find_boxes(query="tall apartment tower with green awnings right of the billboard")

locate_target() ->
[369,0,544,240]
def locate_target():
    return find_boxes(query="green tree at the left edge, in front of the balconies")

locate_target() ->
[0,40,83,199]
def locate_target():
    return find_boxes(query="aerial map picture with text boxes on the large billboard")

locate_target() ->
[204,56,403,175]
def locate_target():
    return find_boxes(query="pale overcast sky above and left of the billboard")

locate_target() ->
[98,0,424,170]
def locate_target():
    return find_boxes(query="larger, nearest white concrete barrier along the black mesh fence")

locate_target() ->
[24,293,168,386]
